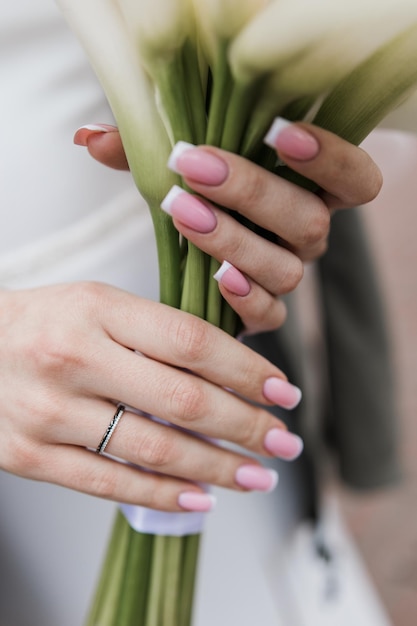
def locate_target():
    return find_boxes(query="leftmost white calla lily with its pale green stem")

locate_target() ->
[56,0,179,305]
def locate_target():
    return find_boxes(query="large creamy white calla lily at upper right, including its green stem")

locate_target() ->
[234,0,417,155]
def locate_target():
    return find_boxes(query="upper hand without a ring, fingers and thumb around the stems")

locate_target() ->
[74,122,382,332]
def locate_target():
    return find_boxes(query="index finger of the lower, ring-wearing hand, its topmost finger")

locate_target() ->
[94,282,300,404]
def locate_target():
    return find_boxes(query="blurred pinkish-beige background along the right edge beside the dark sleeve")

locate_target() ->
[334,97,417,626]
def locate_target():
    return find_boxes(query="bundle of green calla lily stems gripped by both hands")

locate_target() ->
[86,26,417,626]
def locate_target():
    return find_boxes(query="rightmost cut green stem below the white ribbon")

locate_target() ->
[178,534,201,626]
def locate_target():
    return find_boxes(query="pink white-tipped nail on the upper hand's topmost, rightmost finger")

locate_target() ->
[264,117,320,161]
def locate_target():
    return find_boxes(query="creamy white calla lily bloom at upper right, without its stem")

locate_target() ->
[229,0,417,82]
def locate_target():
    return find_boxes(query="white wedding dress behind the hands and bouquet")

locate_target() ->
[0,0,394,626]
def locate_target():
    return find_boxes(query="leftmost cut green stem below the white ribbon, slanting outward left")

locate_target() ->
[86,511,130,626]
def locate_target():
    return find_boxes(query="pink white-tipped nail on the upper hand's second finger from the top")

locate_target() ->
[168,141,229,186]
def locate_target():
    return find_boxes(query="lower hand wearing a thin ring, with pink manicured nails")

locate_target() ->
[0,283,301,511]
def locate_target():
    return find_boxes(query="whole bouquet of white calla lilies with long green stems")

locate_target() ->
[57,0,417,626]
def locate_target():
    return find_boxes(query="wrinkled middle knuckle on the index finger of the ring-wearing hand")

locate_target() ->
[167,315,212,365]
